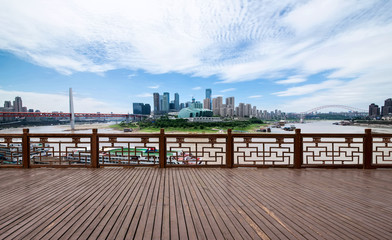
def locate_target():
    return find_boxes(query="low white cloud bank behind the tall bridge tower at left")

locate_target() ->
[0,89,130,113]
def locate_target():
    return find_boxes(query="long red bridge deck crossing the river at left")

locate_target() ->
[0,112,145,118]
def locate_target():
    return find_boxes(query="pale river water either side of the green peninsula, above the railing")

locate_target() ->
[0,121,392,133]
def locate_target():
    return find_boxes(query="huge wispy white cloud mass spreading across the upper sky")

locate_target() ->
[0,0,392,108]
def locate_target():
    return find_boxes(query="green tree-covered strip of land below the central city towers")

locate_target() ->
[110,117,267,133]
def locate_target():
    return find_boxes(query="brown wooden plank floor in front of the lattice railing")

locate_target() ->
[0,168,392,239]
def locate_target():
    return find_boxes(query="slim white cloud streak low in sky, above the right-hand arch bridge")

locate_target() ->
[273,80,343,97]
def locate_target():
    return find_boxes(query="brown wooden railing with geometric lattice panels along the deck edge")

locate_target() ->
[0,129,392,169]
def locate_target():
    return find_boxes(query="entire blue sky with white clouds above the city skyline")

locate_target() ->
[0,0,392,113]
